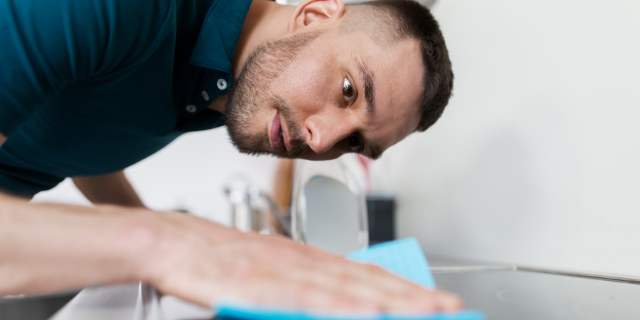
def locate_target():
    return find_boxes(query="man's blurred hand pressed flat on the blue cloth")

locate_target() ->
[149,211,461,311]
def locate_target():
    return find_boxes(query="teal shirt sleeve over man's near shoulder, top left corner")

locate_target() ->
[0,0,170,136]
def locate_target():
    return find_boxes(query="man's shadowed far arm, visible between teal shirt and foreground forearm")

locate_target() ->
[73,171,144,208]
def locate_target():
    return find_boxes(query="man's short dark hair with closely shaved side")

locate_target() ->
[341,0,453,131]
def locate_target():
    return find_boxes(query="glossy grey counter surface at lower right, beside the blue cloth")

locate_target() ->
[434,270,640,320]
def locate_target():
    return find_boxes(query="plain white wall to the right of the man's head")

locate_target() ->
[373,0,640,276]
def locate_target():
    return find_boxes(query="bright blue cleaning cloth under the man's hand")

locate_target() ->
[215,238,485,320]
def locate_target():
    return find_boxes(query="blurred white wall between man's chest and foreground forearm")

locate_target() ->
[34,128,277,224]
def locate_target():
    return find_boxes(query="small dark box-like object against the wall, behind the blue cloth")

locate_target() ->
[367,195,396,245]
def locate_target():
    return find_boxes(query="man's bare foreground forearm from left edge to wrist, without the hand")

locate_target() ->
[0,194,149,296]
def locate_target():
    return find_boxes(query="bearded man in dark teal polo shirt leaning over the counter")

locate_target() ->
[0,0,460,311]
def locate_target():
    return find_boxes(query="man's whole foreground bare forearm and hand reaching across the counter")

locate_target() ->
[0,194,460,311]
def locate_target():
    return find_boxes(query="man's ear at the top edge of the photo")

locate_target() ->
[289,0,344,32]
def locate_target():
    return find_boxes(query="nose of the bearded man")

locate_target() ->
[305,114,352,154]
